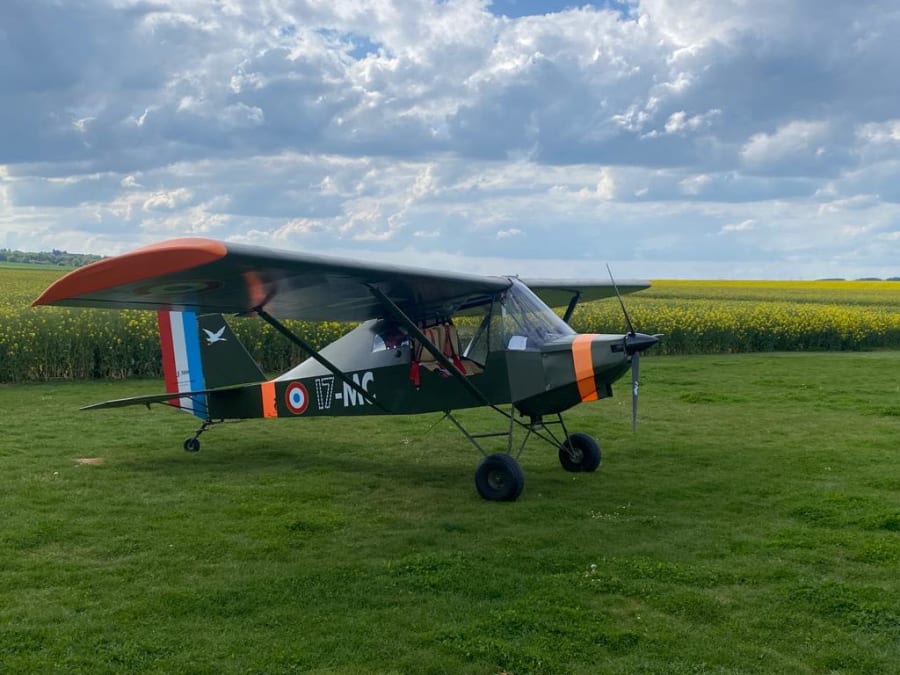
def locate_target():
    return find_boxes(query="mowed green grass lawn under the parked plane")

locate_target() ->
[0,352,900,673]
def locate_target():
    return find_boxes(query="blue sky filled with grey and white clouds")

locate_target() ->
[0,0,900,279]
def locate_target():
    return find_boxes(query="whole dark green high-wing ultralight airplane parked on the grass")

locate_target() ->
[34,238,660,501]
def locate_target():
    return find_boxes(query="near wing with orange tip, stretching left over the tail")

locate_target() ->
[33,238,511,321]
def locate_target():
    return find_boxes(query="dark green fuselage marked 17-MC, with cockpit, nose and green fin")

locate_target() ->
[192,278,656,426]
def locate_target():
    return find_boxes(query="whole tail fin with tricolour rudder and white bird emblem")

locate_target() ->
[157,311,266,419]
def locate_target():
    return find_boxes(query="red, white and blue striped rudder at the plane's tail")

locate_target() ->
[157,310,207,418]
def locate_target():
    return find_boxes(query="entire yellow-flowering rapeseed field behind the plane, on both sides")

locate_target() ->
[0,266,900,382]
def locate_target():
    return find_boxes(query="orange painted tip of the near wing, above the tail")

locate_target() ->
[31,237,228,306]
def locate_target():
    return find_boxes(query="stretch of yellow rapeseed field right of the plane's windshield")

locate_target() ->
[572,280,900,354]
